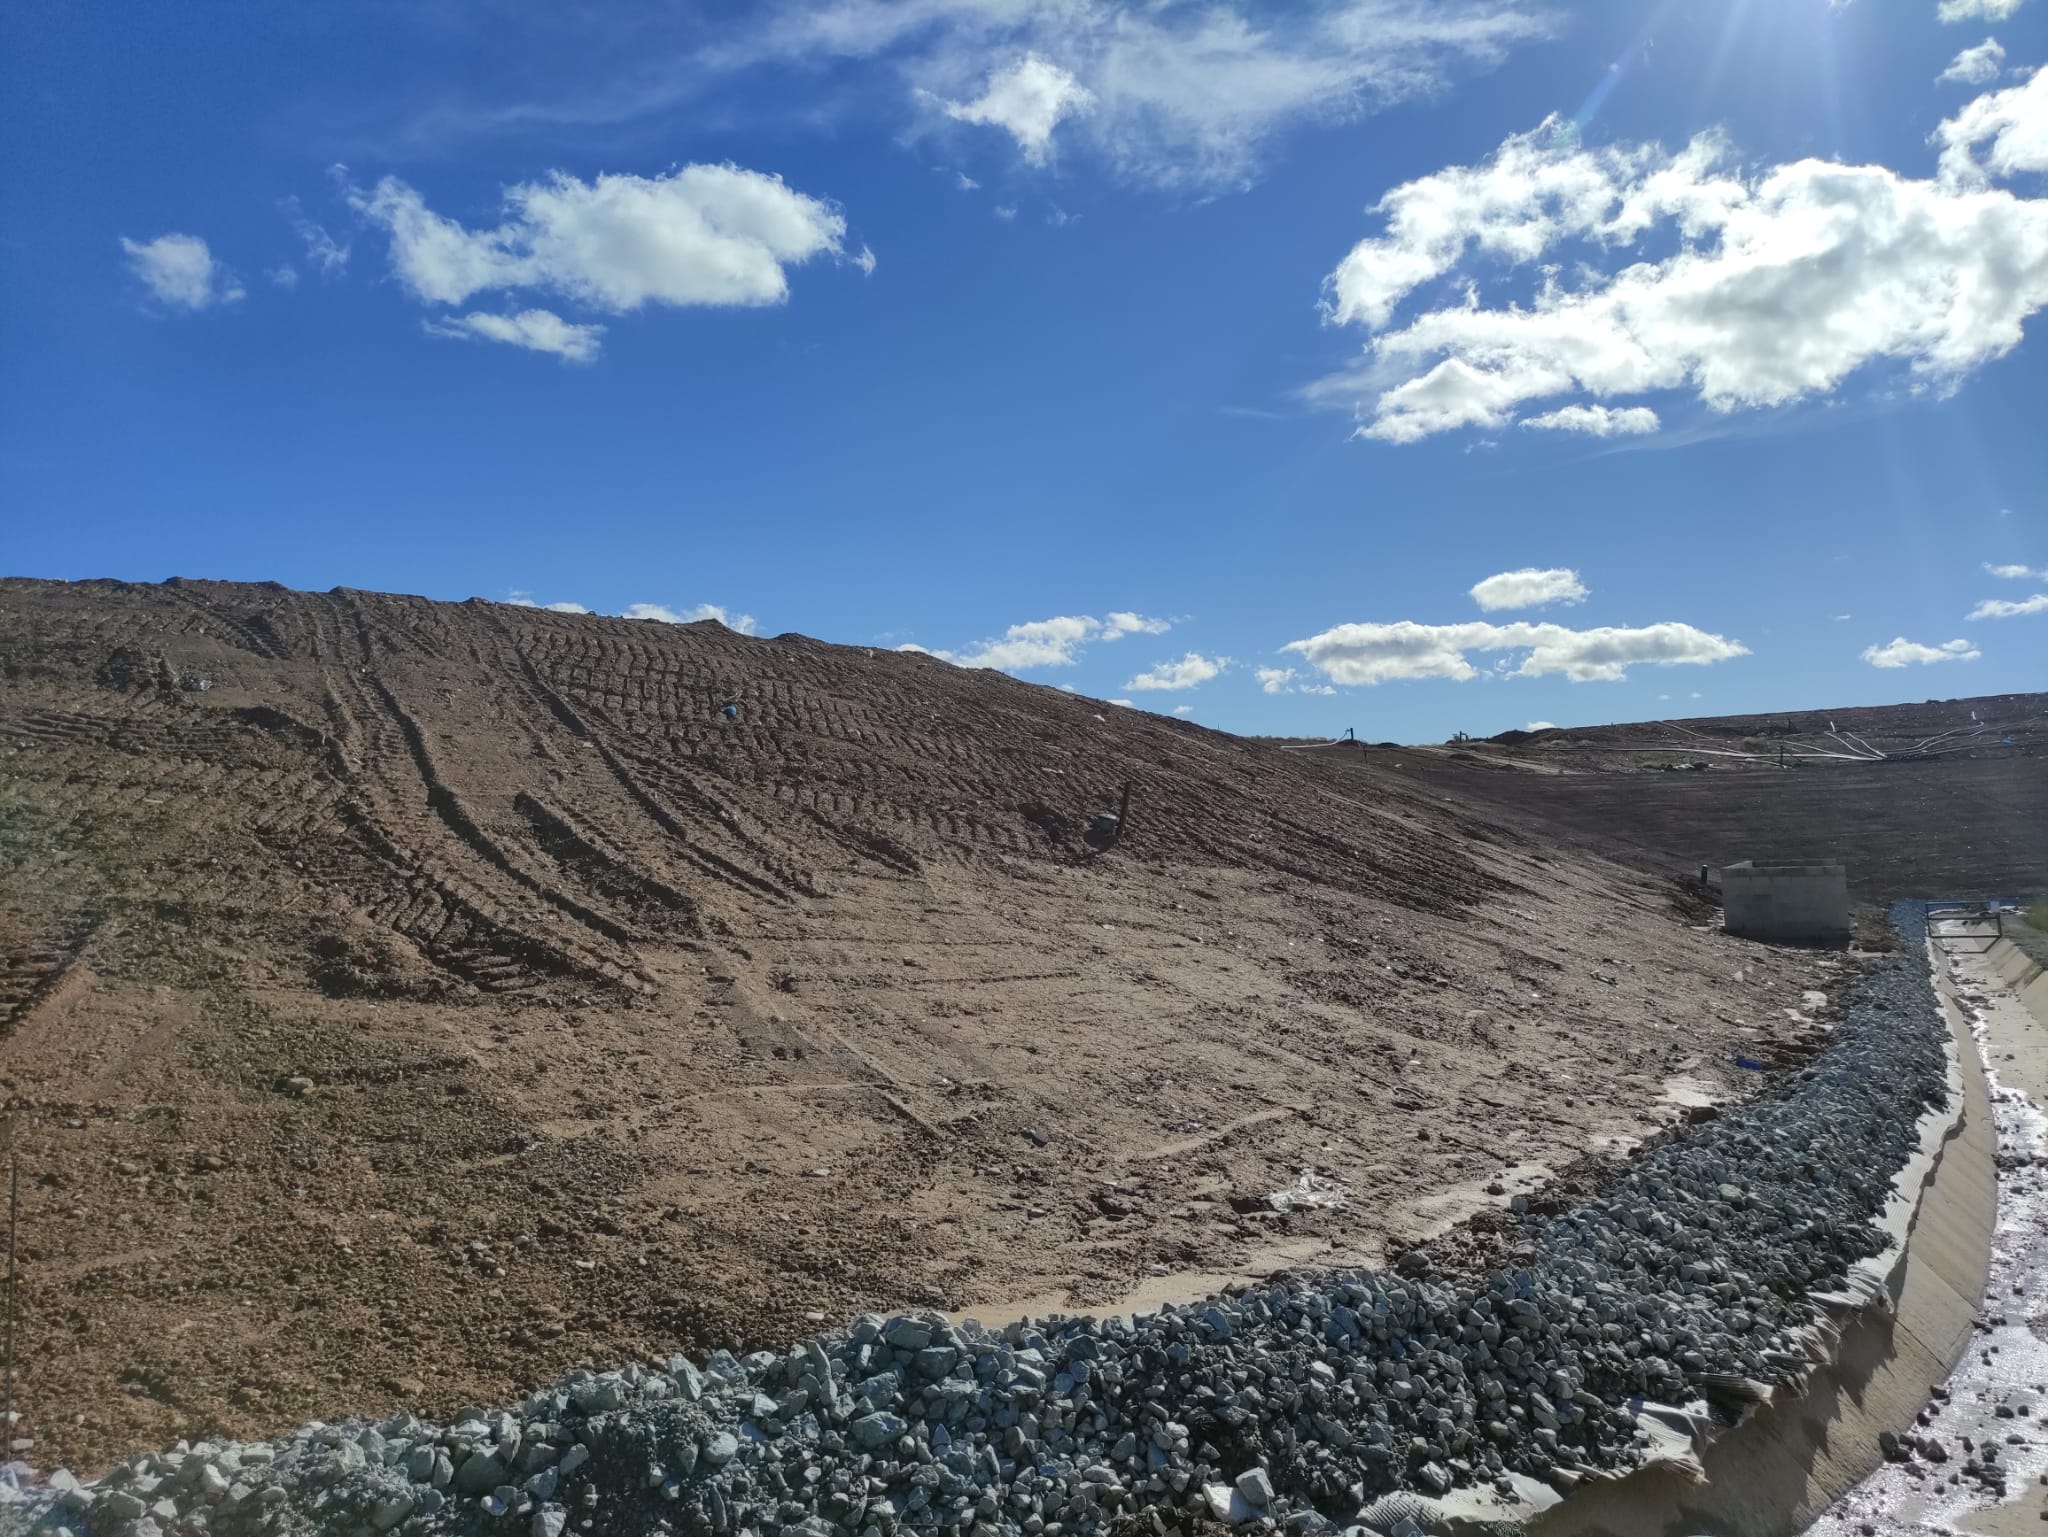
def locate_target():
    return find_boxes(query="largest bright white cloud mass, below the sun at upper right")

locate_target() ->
[1307,72,2048,443]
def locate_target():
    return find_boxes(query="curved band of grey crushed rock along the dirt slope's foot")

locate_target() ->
[0,906,1982,1537]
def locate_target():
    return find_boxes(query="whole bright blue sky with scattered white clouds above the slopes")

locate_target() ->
[0,0,2048,740]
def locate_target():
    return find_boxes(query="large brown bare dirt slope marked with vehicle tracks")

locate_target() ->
[0,582,1837,1465]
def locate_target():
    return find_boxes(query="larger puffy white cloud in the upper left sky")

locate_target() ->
[348,166,860,325]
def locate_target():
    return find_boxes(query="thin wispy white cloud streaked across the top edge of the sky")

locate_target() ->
[379,0,1561,193]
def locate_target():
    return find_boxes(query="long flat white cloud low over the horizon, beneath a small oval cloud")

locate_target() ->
[1282,619,1749,687]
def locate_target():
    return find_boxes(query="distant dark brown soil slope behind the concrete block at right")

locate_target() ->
[1292,695,2048,904]
